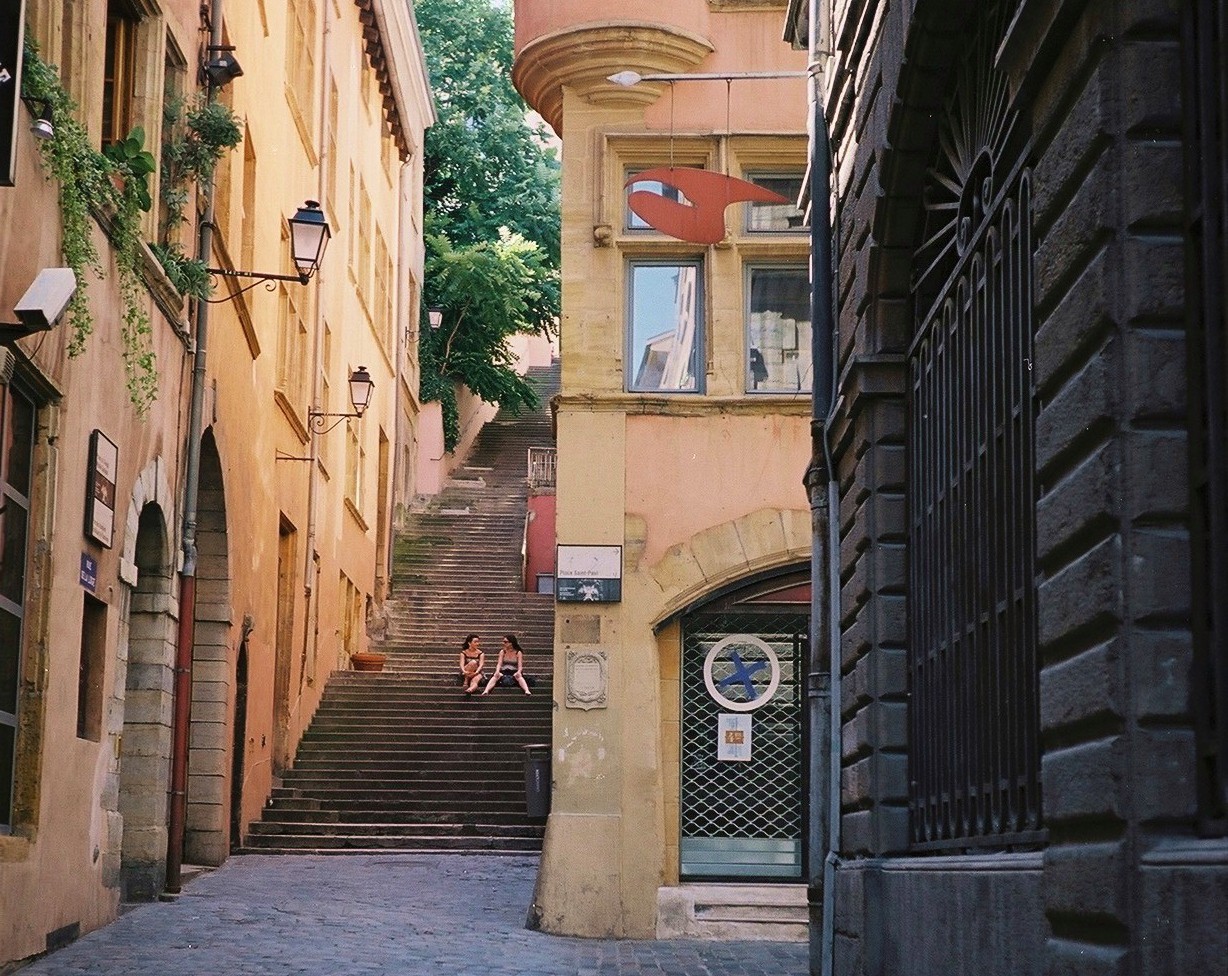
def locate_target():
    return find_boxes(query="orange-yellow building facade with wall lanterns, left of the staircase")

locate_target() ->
[0,0,433,966]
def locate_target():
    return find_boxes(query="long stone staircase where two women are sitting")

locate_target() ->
[243,363,559,853]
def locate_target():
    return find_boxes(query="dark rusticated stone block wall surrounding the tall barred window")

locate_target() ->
[828,0,1228,976]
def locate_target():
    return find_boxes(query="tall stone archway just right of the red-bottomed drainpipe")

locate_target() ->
[184,428,236,864]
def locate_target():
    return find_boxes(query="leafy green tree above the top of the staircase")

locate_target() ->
[415,0,559,451]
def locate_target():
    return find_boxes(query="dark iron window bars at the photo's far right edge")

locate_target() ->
[1183,0,1228,834]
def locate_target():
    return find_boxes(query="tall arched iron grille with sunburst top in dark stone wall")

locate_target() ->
[907,5,1041,848]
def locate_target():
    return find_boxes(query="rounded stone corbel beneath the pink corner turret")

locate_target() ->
[512,21,713,135]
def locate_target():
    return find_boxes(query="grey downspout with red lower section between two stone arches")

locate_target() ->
[166,0,223,895]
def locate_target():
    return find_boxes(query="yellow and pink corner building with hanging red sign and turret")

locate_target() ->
[513,0,812,937]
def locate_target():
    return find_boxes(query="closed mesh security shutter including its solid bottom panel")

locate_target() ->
[680,606,808,878]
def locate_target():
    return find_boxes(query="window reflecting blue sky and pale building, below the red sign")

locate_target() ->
[626,260,704,393]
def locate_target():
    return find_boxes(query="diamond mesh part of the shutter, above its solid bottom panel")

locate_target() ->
[682,610,808,843]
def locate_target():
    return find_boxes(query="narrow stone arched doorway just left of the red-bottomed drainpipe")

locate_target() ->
[119,503,176,901]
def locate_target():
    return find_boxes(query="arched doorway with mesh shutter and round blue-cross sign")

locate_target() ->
[679,571,810,881]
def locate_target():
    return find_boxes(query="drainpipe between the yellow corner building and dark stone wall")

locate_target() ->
[806,0,841,976]
